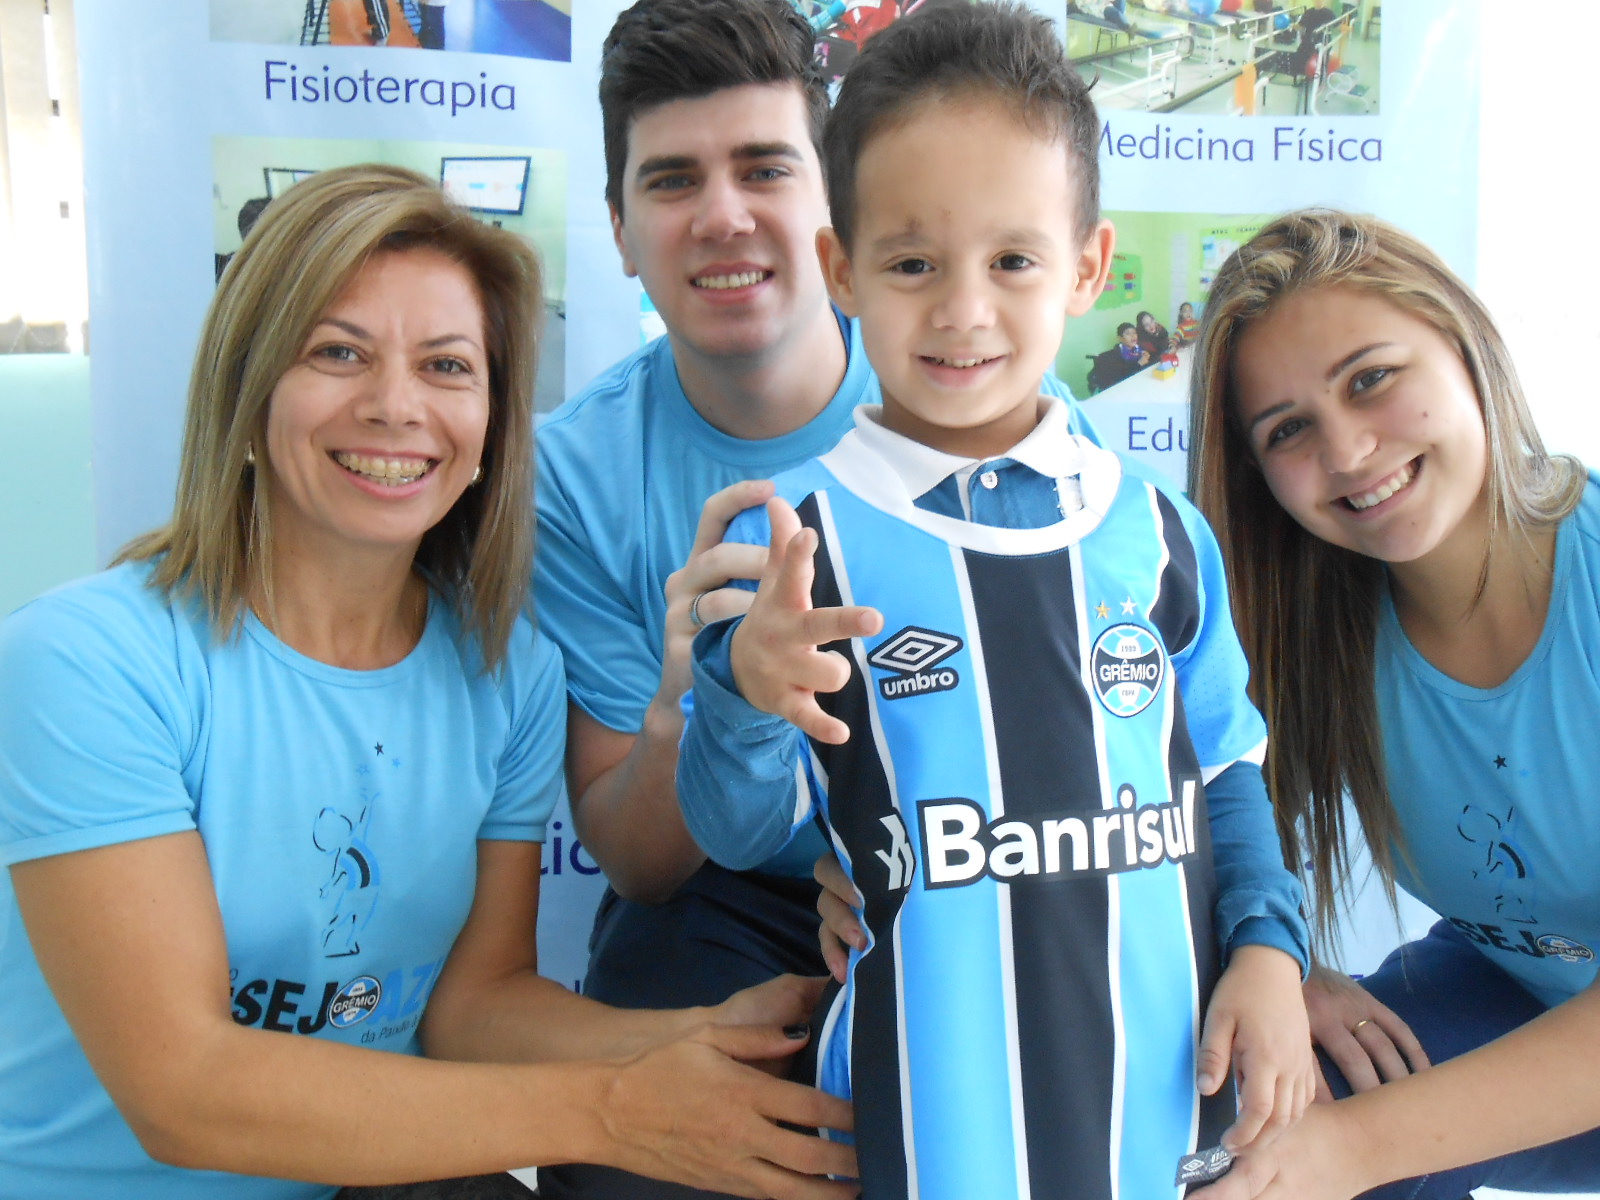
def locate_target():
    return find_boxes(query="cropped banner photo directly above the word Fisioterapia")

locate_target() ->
[210,0,573,62]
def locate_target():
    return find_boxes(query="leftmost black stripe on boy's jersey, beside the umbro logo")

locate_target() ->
[797,496,910,1200]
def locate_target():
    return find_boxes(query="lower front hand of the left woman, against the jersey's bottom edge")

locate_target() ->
[597,1024,859,1200]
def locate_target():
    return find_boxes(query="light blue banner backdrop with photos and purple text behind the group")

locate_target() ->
[78,0,1480,986]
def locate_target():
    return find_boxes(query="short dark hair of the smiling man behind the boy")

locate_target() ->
[600,0,827,214]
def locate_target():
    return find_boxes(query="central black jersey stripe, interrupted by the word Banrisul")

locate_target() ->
[965,550,1114,1200]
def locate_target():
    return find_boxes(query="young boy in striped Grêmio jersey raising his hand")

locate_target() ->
[678,5,1312,1200]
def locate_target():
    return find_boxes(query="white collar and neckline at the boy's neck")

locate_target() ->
[819,400,1122,555]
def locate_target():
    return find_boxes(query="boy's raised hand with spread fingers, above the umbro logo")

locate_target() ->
[728,496,883,746]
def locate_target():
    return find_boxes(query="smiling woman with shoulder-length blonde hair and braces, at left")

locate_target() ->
[0,166,853,1200]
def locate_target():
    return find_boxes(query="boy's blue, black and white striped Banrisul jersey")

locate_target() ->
[779,435,1262,1200]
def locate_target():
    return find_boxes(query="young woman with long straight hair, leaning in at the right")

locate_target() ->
[1190,211,1600,1200]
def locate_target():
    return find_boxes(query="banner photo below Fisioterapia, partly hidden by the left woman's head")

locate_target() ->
[211,136,566,413]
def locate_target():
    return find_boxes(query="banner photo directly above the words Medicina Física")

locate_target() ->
[1067,0,1382,117]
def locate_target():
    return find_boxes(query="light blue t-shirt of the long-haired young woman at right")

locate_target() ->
[1378,474,1600,1005]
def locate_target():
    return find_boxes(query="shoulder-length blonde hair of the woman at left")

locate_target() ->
[118,165,544,667]
